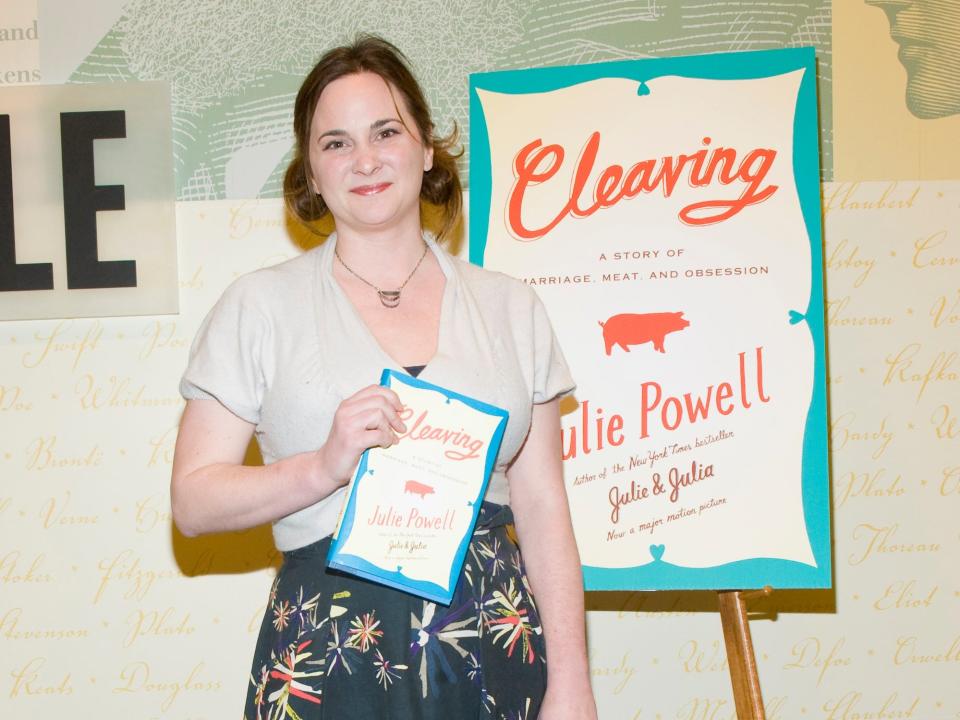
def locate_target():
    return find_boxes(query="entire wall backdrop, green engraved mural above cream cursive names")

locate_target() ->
[0,0,960,720]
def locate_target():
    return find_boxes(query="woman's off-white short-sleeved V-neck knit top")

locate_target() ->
[180,235,574,551]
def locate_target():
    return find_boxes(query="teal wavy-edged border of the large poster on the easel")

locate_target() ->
[469,47,832,590]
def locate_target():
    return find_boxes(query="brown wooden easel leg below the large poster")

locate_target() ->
[717,585,773,720]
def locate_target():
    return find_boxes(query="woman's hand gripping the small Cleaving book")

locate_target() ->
[317,385,407,488]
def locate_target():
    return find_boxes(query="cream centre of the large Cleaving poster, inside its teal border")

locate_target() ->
[475,69,812,576]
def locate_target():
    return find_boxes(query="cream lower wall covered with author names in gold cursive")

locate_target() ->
[0,0,960,720]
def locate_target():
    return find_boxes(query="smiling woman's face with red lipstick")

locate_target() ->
[309,72,433,232]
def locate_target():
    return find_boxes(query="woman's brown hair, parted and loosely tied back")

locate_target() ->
[283,35,463,239]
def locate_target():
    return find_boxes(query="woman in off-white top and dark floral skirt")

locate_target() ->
[171,37,596,720]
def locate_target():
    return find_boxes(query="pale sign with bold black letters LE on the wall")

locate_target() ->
[0,82,179,320]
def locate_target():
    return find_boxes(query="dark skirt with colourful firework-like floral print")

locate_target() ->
[244,503,546,720]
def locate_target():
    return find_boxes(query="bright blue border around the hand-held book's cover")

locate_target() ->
[327,369,510,605]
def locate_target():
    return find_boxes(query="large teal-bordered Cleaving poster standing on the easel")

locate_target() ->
[470,48,831,590]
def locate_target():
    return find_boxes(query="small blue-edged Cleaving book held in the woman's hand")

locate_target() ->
[327,369,508,605]
